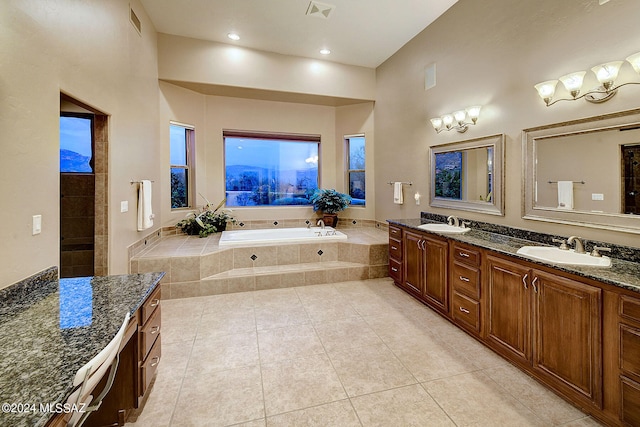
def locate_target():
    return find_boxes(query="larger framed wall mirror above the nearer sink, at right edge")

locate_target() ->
[522,109,640,233]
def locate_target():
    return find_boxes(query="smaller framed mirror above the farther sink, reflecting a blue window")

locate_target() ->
[429,134,504,215]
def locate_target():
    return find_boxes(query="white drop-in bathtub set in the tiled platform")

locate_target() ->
[219,227,347,247]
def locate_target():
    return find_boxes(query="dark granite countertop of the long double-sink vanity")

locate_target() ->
[387,218,640,293]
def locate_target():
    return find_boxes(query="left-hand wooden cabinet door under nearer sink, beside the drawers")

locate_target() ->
[486,256,531,364]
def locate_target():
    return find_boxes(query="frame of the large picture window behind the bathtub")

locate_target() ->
[222,129,322,209]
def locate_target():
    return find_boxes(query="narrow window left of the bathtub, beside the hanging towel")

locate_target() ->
[169,123,195,209]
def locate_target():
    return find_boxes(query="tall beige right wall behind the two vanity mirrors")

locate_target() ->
[375,0,640,246]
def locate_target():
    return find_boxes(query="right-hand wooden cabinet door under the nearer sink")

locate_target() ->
[531,271,602,406]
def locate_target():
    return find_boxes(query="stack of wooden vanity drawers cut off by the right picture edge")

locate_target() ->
[618,295,640,426]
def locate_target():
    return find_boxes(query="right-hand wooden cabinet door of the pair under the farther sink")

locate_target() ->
[424,237,449,313]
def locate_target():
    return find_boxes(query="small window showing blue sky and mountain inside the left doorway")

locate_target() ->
[60,113,93,173]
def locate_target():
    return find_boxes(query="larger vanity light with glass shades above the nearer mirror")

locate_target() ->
[535,52,640,107]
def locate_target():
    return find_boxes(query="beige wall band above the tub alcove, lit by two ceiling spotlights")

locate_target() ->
[158,34,375,99]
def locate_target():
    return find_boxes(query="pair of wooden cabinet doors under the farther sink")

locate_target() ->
[402,230,449,315]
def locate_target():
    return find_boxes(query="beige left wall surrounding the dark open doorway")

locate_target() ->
[0,0,160,288]
